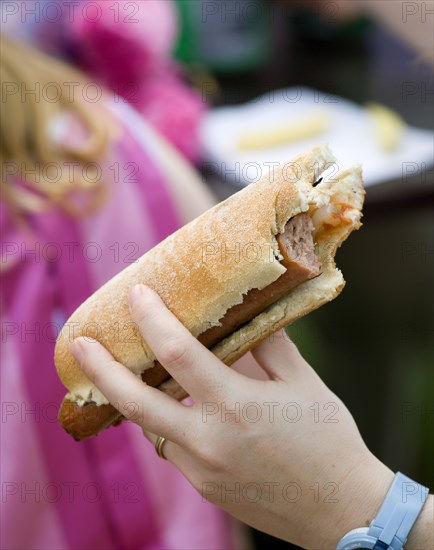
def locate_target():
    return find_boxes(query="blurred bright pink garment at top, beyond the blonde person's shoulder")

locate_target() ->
[68,0,206,162]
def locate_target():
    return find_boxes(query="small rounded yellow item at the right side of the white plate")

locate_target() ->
[366,103,405,153]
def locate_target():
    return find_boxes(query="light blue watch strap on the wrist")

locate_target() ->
[367,472,428,550]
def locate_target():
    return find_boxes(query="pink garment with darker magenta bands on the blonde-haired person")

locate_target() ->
[0,106,237,550]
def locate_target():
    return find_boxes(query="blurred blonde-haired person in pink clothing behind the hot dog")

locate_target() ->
[0,37,245,550]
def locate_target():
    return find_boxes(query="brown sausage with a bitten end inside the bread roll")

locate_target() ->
[58,214,321,441]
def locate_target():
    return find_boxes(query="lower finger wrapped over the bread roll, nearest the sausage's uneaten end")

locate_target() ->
[71,338,191,441]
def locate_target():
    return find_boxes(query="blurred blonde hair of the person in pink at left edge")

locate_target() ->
[0,36,109,217]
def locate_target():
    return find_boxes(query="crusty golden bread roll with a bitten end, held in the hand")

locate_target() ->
[55,146,364,438]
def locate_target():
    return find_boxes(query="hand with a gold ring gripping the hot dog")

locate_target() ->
[71,285,393,549]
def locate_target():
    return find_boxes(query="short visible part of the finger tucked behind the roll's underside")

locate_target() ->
[252,330,307,381]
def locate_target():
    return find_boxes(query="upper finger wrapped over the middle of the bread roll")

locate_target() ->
[130,285,240,400]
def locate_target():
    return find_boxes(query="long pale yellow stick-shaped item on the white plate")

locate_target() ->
[237,112,330,151]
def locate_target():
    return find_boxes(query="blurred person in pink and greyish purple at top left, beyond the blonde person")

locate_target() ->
[2,0,205,162]
